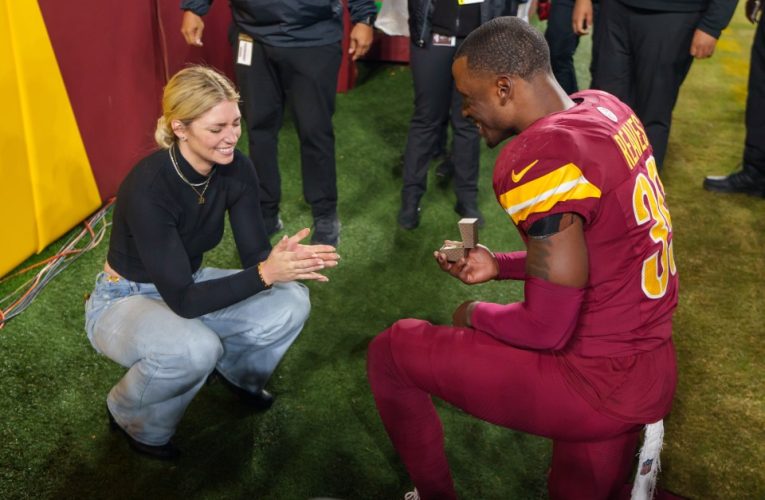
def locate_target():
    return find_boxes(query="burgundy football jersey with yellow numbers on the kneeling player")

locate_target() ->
[494,90,678,357]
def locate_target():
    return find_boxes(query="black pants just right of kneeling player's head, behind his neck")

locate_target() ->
[545,0,599,94]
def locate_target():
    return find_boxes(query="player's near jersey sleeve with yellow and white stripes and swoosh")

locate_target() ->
[494,130,601,233]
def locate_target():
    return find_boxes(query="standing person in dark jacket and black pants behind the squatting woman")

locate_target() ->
[181,0,376,245]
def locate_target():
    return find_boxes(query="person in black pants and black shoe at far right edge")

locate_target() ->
[704,0,765,198]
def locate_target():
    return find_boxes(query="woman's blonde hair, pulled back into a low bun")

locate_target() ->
[154,66,239,149]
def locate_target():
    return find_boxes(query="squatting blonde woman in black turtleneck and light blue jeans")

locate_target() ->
[86,66,339,459]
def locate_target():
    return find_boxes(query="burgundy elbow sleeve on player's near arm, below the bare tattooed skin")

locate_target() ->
[470,277,584,350]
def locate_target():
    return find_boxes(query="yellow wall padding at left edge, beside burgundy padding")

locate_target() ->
[0,0,101,275]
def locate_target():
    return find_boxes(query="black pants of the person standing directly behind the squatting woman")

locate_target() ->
[234,42,342,220]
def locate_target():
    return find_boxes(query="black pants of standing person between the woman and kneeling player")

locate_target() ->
[401,41,480,206]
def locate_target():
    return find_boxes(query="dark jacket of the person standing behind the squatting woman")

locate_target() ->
[181,0,377,47]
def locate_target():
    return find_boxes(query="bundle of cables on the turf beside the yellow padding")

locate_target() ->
[0,198,115,329]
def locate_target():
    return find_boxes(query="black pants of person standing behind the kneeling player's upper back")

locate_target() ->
[593,0,701,168]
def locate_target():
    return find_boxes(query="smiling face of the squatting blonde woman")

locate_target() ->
[174,101,242,175]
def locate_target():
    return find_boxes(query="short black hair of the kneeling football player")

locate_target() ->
[454,16,552,80]
